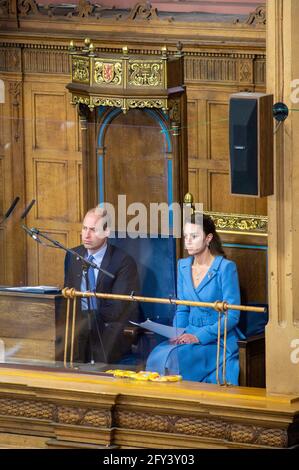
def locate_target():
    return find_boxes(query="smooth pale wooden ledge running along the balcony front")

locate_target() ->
[0,367,299,412]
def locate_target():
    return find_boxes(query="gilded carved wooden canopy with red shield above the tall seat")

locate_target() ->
[67,39,184,112]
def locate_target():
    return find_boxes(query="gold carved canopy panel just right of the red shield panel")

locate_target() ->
[128,61,163,87]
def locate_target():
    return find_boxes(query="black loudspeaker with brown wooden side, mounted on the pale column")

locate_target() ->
[229,93,273,197]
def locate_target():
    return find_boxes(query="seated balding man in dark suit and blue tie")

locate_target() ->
[64,207,139,363]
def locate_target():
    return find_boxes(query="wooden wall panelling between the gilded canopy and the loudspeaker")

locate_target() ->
[187,87,267,215]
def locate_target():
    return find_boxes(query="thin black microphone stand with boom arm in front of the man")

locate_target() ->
[26,226,115,364]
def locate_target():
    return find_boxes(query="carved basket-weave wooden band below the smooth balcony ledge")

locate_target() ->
[0,398,297,448]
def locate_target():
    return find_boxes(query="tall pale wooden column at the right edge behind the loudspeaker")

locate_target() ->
[266,0,299,395]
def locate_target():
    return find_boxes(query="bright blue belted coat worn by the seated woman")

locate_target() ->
[146,256,243,385]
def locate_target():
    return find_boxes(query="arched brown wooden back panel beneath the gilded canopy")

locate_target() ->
[104,109,167,208]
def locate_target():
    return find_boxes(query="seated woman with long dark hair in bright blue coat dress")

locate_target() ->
[146,214,244,385]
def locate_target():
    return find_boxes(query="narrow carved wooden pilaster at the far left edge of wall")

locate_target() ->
[0,53,26,285]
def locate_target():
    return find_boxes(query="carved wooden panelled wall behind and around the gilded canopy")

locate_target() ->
[0,0,267,298]
